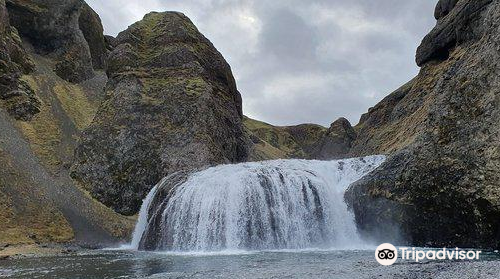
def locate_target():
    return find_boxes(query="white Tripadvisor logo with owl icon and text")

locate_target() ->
[375,243,481,265]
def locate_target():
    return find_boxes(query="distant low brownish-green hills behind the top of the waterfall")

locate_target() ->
[244,117,356,161]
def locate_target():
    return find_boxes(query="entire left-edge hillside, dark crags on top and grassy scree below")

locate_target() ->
[0,0,134,248]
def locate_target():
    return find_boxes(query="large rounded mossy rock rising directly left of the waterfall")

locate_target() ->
[72,12,248,215]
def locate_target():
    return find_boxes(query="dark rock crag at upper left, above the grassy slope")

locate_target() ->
[6,0,106,82]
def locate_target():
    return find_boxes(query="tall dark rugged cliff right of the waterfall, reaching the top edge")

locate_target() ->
[346,0,500,248]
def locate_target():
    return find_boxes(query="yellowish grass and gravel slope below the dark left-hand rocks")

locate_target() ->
[0,52,134,247]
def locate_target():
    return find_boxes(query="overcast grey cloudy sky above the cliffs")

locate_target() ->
[87,0,437,126]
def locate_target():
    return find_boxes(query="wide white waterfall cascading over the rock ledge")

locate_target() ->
[132,156,385,251]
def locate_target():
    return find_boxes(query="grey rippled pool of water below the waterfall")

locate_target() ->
[0,250,500,279]
